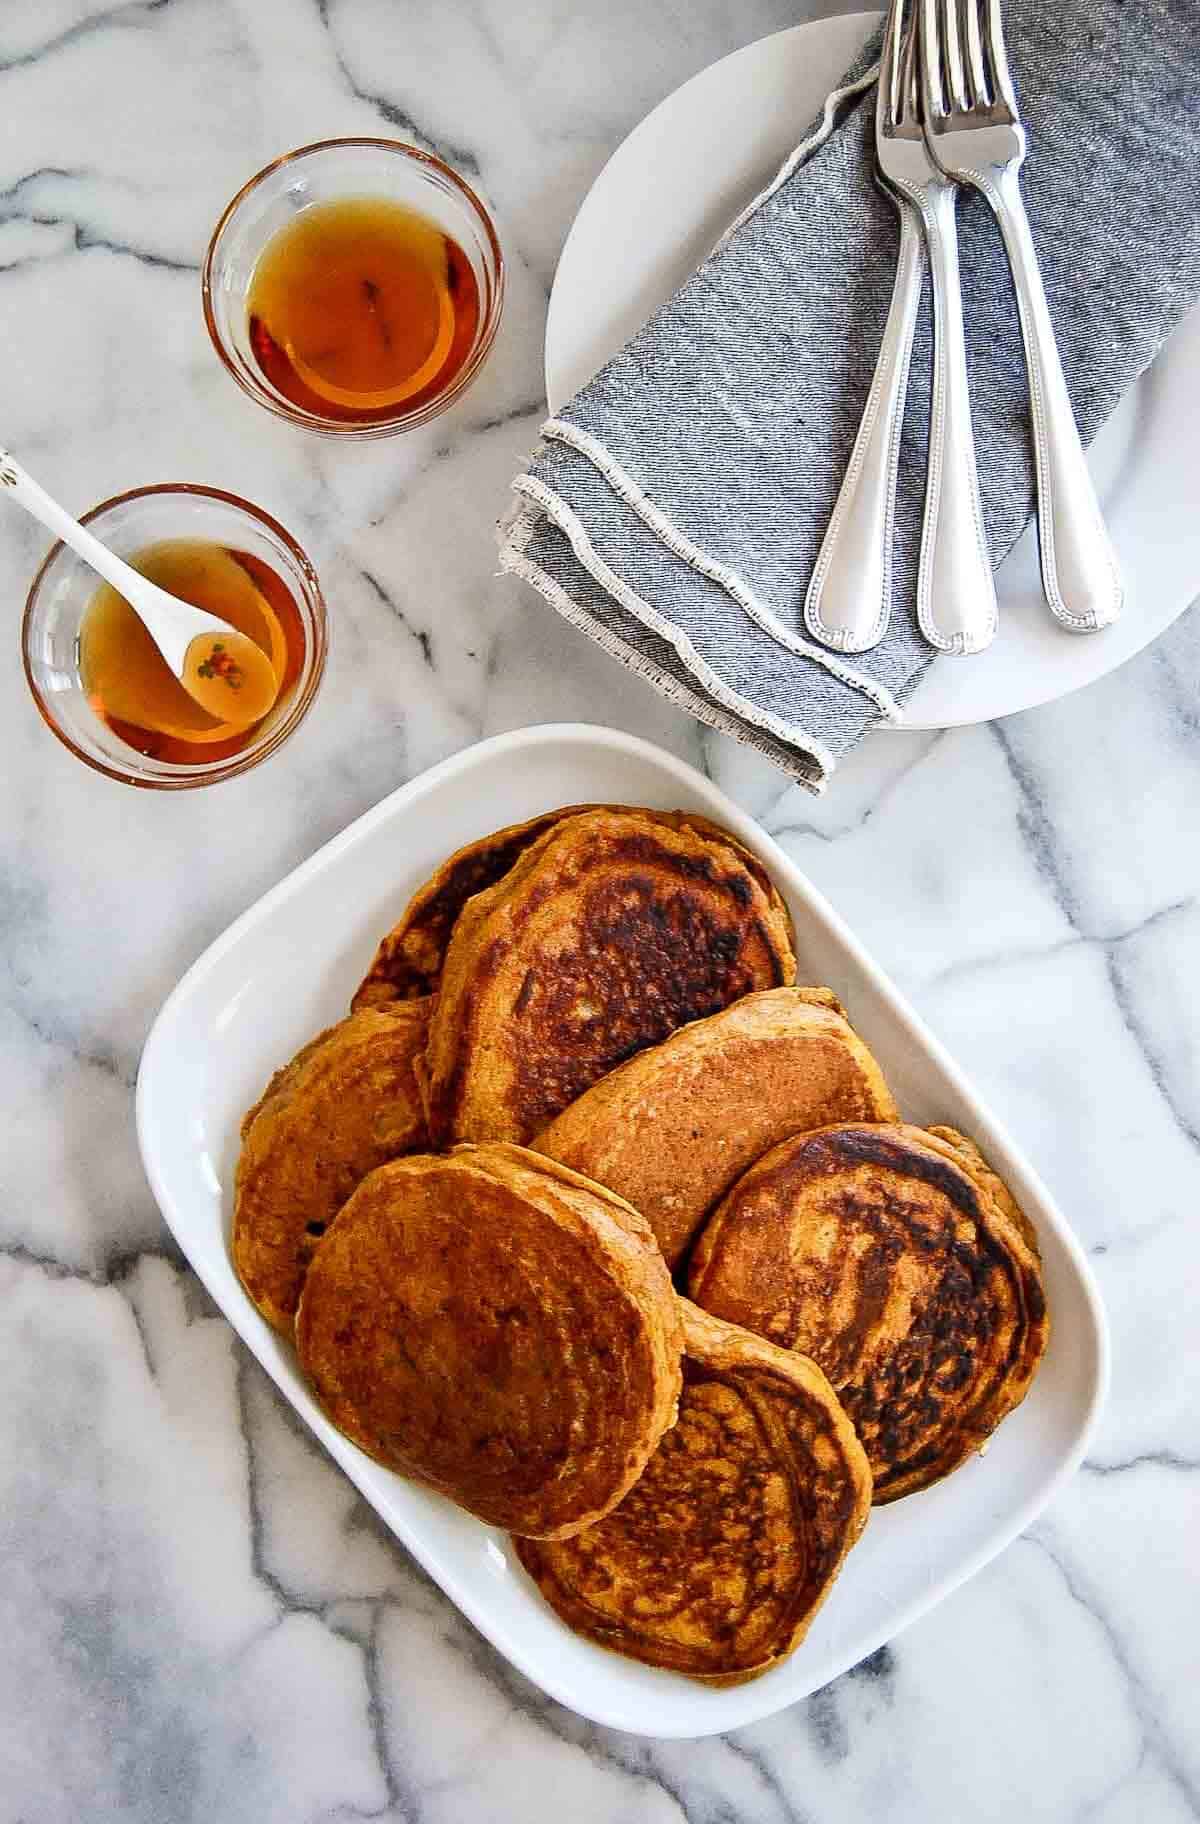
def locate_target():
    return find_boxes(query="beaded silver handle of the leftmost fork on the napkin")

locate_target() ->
[804,205,923,653]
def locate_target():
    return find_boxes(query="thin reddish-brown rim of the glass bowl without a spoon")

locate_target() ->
[201,133,507,441]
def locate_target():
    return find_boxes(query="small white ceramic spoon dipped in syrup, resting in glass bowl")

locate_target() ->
[0,449,279,728]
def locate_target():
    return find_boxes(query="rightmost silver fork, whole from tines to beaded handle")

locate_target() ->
[921,0,1123,633]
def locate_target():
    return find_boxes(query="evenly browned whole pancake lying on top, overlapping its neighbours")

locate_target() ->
[295,1145,682,1538]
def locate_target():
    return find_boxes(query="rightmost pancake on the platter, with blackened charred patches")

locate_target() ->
[688,1124,1049,1501]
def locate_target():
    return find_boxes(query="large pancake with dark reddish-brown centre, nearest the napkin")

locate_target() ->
[419,810,795,1145]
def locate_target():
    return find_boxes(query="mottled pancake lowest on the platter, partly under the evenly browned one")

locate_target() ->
[516,1301,872,1685]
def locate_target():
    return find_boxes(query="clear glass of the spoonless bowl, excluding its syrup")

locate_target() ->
[202,139,503,438]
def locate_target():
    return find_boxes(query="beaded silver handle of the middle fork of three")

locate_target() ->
[914,182,996,653]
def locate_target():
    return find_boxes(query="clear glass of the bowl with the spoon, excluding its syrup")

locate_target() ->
[22,482,326,792]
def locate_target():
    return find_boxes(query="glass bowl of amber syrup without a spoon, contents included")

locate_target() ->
[204,139,503,438]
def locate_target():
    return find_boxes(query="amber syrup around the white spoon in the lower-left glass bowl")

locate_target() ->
[78,538,306,766]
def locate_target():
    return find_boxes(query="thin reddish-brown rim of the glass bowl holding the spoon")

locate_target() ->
[20,482,328,792]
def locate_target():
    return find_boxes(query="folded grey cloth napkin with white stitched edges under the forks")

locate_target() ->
[500,0,1200,790]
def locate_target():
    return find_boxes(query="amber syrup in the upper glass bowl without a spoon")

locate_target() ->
[248,197,480,423]
